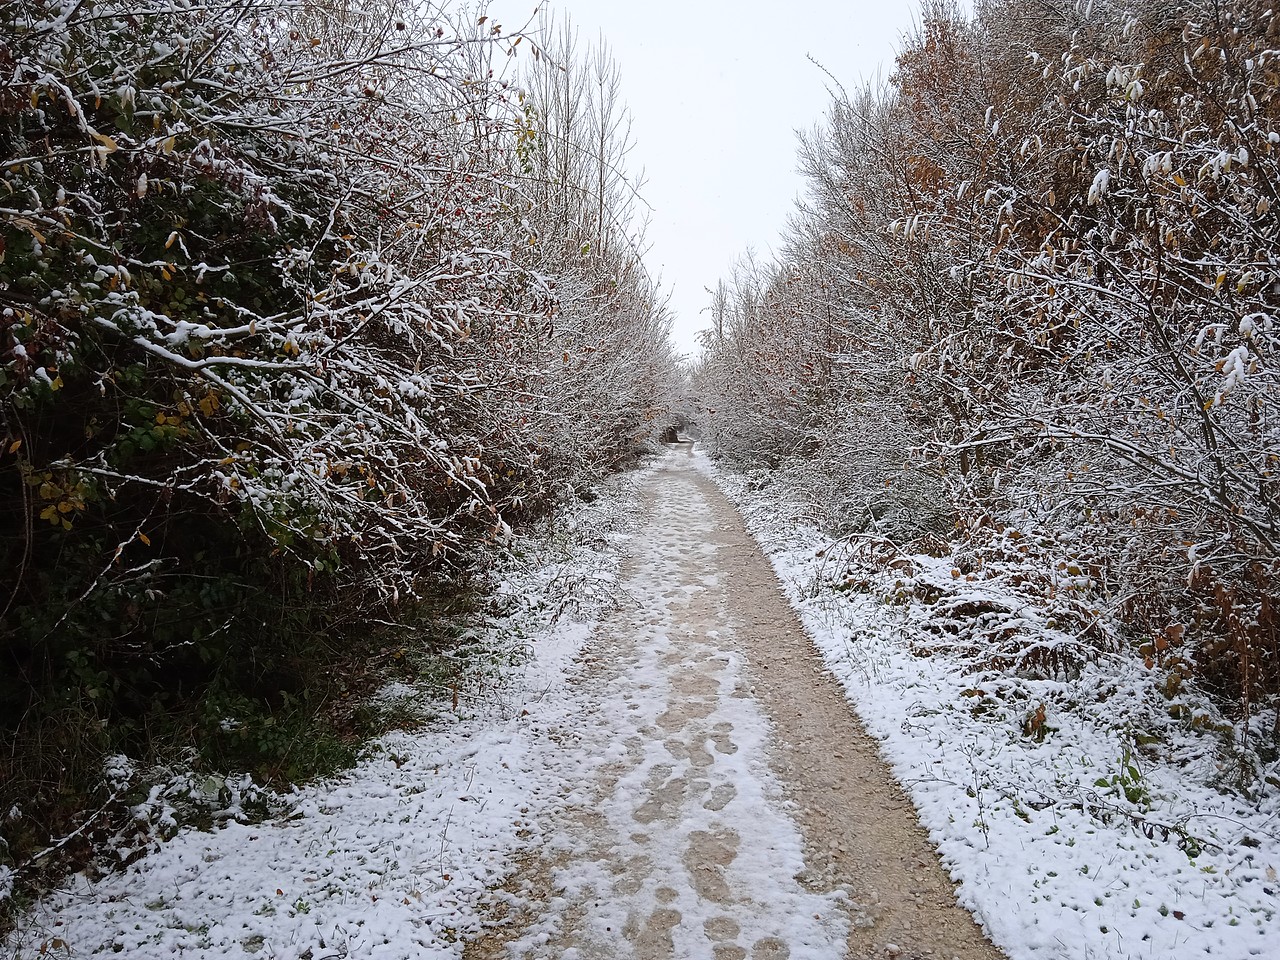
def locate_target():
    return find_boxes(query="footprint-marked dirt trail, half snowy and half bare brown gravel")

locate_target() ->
[467,448,1001,960]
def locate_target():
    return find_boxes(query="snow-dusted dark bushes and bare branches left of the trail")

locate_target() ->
[0,0,672,916]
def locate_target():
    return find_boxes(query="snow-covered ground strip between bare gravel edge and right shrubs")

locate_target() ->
[700,457,1280,960]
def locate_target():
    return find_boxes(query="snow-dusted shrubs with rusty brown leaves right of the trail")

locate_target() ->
[700,0,1280,788]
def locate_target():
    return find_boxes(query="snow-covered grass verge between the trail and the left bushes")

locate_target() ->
[0,476,650,960]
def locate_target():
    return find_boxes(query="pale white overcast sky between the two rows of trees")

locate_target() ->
[489,0,918,353]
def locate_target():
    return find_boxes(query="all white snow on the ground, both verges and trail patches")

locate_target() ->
[12,450,1280,960]
